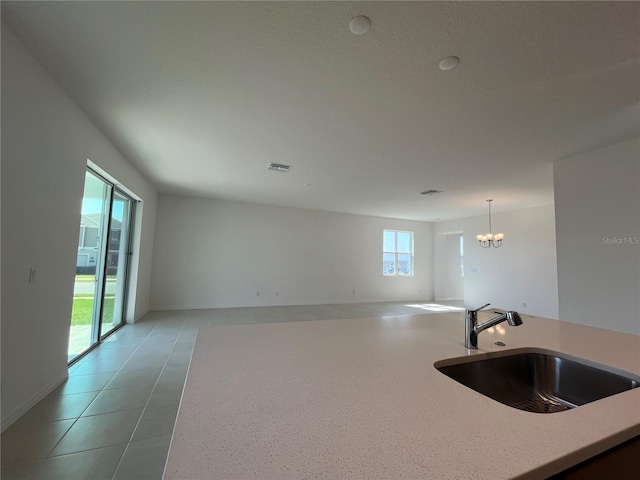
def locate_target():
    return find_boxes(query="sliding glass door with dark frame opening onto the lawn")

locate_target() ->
[68,170,133,363]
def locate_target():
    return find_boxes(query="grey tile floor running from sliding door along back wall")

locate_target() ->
[1,302,461,480]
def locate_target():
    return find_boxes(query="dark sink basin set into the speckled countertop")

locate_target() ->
[434,348,640,413]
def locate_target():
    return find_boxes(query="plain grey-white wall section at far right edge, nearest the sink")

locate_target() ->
[553,139,640,334]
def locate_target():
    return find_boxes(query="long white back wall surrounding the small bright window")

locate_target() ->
[151,194,433,309]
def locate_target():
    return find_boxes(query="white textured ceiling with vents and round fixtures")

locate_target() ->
[2,1,640,221]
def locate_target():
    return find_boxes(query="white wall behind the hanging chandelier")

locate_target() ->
[435,205,558,319]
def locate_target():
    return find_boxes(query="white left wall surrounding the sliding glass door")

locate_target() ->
[1,25,157,429]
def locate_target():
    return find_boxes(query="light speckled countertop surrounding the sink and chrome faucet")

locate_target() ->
[165,313,640,480]
